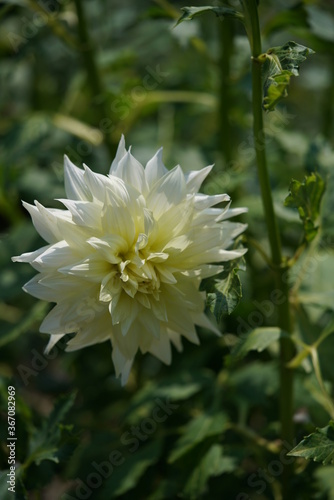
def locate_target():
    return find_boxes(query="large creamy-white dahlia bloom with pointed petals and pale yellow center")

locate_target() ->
[13,137,246,384]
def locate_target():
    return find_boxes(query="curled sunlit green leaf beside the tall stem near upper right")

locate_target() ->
[257,42,314,111]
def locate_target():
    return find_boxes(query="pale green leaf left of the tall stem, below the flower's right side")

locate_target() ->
[232,326,289,359]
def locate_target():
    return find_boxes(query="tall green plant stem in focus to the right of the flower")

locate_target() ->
[243,0,294,488]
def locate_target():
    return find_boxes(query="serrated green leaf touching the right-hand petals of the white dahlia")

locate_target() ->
[207,269,242,322]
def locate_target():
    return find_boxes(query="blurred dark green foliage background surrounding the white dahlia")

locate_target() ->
[0,0,334,500]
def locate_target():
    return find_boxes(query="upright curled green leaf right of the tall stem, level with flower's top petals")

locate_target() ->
[284,173,326,242]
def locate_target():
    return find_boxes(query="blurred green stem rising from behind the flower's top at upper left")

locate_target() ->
[74,0,116,158]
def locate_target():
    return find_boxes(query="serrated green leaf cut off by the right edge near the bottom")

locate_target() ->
[288,420,334,465]
